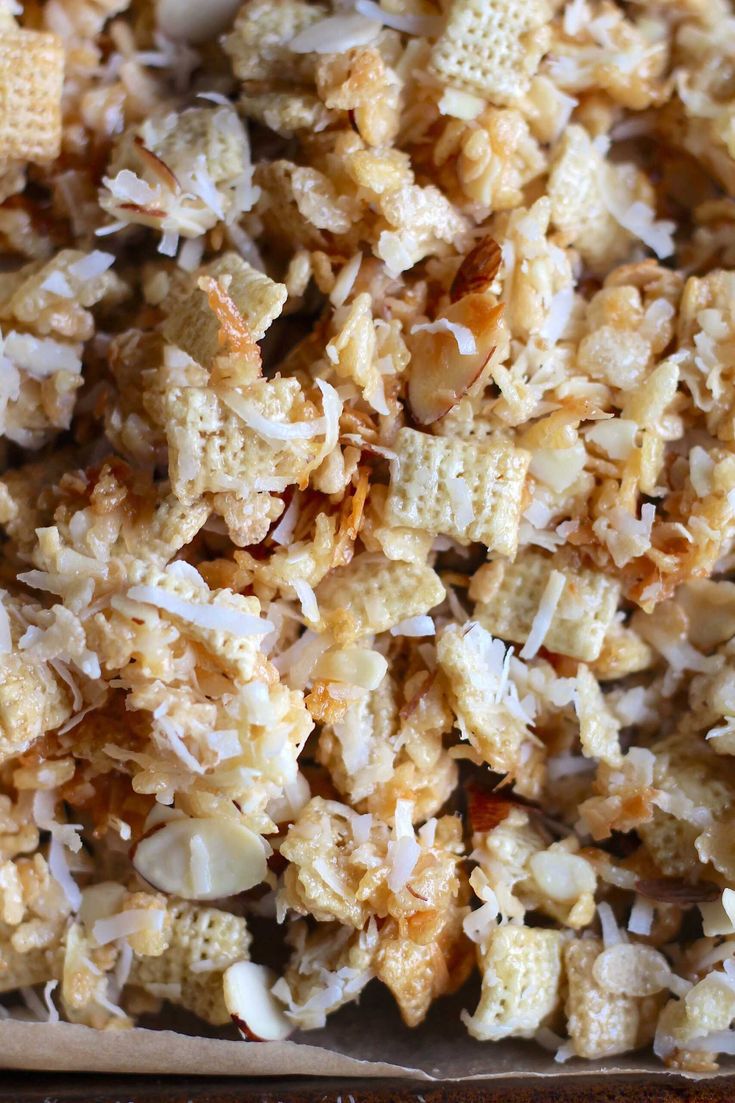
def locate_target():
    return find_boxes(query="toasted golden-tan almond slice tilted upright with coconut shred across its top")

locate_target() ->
[408,295,503,425]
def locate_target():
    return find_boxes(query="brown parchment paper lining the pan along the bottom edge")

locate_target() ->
[0,986,735,1080]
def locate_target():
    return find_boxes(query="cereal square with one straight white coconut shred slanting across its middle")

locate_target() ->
[475,549,620,662]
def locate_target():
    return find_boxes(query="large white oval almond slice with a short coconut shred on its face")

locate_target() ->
[132,818,267,900]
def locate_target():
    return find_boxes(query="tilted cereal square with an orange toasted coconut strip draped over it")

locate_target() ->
[163,253,287,368]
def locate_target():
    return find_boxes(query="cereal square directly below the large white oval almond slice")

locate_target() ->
[129,900,251,1026]
